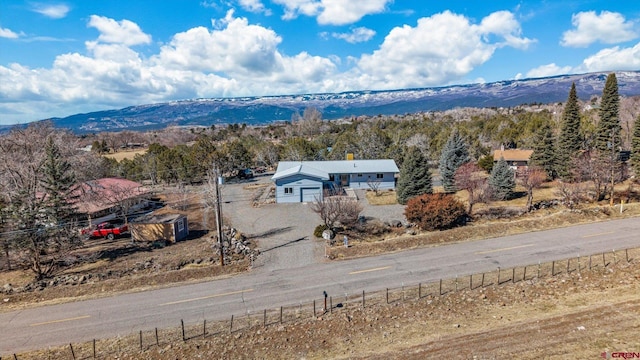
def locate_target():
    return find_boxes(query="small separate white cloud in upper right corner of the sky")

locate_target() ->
[560,11,638,47]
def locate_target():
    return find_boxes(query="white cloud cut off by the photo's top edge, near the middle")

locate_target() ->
[273,0,393,25]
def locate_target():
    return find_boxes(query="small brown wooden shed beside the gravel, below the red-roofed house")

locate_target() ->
[129,214,189,243]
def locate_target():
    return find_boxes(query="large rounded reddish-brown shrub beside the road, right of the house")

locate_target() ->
[404,194,467,231]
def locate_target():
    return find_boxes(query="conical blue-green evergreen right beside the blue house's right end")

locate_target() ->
[396,146,433,205]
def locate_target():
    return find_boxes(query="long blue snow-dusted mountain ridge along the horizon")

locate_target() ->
[32,71,640,133]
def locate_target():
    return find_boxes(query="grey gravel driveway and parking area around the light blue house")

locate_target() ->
[221,175,404,271]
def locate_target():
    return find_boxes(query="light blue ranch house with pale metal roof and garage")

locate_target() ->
[271,159,399,203]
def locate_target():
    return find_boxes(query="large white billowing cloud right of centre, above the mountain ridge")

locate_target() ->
[352,11,533,89]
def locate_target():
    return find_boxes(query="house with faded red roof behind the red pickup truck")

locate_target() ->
[73,178,151,223]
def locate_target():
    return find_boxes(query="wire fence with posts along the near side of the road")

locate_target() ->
[6,248,640,360]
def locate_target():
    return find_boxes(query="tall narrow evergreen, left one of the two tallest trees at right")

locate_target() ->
[556,83,582,178]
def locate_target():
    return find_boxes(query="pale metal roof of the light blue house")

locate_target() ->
[272,159,400,180]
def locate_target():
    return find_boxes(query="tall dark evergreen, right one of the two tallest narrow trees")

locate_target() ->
[596,73,621,153]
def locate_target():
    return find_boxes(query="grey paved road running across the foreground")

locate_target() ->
[0,215,640,356]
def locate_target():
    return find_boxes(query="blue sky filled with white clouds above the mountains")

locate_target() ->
[0,0,640,124]
